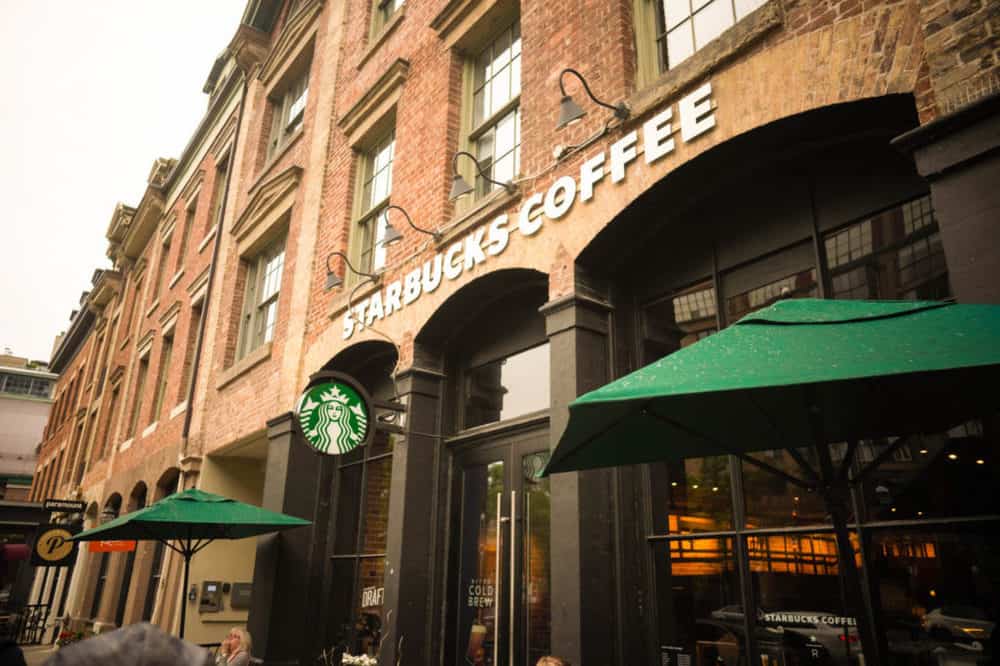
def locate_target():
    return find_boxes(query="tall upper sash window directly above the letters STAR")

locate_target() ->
[355,130,396,273]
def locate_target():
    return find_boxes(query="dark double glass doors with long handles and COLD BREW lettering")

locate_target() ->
[449,426,551,666]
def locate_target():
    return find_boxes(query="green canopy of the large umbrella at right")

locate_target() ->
[546,299,1000,473]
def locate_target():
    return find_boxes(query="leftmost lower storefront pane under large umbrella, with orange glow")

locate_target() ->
[653,539,746,666]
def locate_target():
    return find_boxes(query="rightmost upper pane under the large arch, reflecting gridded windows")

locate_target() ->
[823,196,951,299]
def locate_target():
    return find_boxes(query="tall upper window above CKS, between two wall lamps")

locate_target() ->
[468,20,521,197]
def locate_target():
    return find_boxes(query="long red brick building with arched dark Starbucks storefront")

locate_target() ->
[27,0,1000,664]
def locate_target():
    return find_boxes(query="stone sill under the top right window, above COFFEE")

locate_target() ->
[626,0,783,118]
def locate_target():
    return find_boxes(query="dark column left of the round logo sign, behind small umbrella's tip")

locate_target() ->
[247,413,332,665]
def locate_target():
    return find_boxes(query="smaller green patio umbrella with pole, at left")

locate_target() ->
[72,488,311,638]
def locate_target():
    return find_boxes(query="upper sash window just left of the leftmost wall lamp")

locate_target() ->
[238,238,285,358]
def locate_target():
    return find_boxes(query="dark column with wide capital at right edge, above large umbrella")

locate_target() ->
[893,93,1000,303]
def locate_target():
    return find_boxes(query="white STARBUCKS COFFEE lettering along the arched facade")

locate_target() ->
[343,83,715,340]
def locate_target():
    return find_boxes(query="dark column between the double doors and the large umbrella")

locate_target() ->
[541,294,618,665]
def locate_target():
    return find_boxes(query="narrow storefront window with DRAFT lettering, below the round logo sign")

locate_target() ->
[331,432,393,655]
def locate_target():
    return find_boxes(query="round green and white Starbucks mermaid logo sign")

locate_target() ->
[295,380,369,455]
